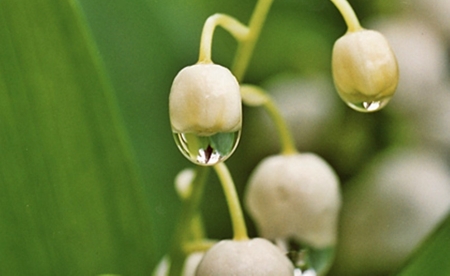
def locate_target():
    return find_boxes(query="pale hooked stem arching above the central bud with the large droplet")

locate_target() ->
[198,13,249,63]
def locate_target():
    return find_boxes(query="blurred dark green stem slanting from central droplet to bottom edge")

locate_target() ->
[168,166,209,276]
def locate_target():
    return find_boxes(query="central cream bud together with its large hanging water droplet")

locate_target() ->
[169,63,242,166]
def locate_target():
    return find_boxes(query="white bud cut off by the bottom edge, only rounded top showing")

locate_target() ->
[196,238,294,276]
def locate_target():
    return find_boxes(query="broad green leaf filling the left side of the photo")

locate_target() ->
[0,0,154,275]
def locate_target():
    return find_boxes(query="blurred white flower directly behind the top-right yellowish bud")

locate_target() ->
[371,15,450,116]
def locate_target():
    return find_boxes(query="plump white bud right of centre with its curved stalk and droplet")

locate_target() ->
[241,85,341,275]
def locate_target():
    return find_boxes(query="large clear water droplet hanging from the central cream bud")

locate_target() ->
[173,130,241,166]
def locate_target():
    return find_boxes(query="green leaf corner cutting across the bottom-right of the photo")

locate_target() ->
[396,212,450,276]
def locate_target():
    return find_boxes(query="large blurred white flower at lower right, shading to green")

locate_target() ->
[333,150,450,275]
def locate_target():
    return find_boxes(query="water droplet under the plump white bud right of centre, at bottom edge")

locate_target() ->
[289,244,335,276]
